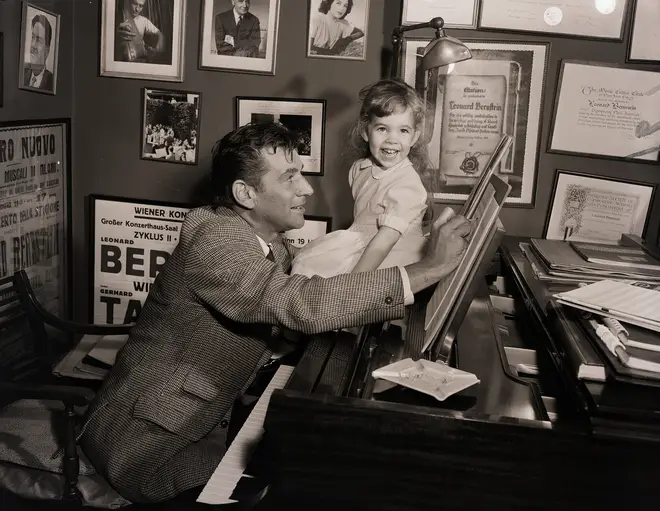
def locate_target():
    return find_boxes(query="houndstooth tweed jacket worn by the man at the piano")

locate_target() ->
[81,207,405,502]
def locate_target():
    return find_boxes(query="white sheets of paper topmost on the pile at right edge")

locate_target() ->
[555,280,660,332]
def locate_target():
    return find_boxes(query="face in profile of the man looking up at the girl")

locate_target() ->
[252,148,314,233]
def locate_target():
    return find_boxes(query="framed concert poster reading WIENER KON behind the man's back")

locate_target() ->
[88,195,191,325]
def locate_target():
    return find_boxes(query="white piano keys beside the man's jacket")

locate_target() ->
[197,365,293,504]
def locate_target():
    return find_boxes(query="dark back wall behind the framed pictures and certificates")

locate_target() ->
[68,0,660,318]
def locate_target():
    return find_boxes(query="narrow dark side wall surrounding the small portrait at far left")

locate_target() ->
[0,0,74,122]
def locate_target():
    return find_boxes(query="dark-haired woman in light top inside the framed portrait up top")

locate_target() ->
[309,0,364,55]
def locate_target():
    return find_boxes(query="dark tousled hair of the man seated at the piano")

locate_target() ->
[211,122,300,207]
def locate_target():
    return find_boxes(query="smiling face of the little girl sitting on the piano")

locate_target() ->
[362,108,420,169]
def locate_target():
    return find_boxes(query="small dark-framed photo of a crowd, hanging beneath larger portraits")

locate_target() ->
[141,88,202,165]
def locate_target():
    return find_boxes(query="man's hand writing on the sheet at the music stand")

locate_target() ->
[406,208,470,293]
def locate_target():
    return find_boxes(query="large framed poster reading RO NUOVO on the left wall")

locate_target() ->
[0,118,72,326]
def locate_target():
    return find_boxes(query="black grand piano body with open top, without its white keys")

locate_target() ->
[264,236,660,511]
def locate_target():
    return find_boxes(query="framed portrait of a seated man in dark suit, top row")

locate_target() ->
[199,0,280,75]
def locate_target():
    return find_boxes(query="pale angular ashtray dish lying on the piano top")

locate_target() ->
[371,358,479,401]
